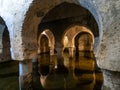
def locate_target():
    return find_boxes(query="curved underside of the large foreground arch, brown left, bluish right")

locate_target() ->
[22,0,102,58]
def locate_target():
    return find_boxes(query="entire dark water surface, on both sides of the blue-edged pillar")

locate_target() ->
[0,53,103,90]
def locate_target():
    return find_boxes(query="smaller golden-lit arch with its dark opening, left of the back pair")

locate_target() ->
[38,29,55,55]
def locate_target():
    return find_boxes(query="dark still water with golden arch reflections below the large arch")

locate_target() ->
[33,52,103,90]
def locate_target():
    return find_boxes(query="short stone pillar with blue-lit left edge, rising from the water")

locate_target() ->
[19,60,32,90]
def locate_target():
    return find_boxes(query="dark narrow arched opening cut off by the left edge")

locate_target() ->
[0,17,11,62]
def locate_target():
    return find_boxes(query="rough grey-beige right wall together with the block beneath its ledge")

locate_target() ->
[96,0,120,90]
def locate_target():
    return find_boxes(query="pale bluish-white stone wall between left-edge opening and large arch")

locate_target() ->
[0,0,32,60]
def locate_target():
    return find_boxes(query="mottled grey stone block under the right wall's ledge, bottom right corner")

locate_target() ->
[102,70,120,90]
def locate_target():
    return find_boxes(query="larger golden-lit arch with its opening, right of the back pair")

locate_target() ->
[62,25,94,56]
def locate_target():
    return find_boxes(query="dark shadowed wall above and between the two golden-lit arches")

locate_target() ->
[38,2,99,55]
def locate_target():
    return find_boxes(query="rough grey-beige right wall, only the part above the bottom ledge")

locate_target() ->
[96,0,120,71]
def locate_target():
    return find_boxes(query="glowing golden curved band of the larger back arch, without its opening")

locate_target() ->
[62,25,94,51]
